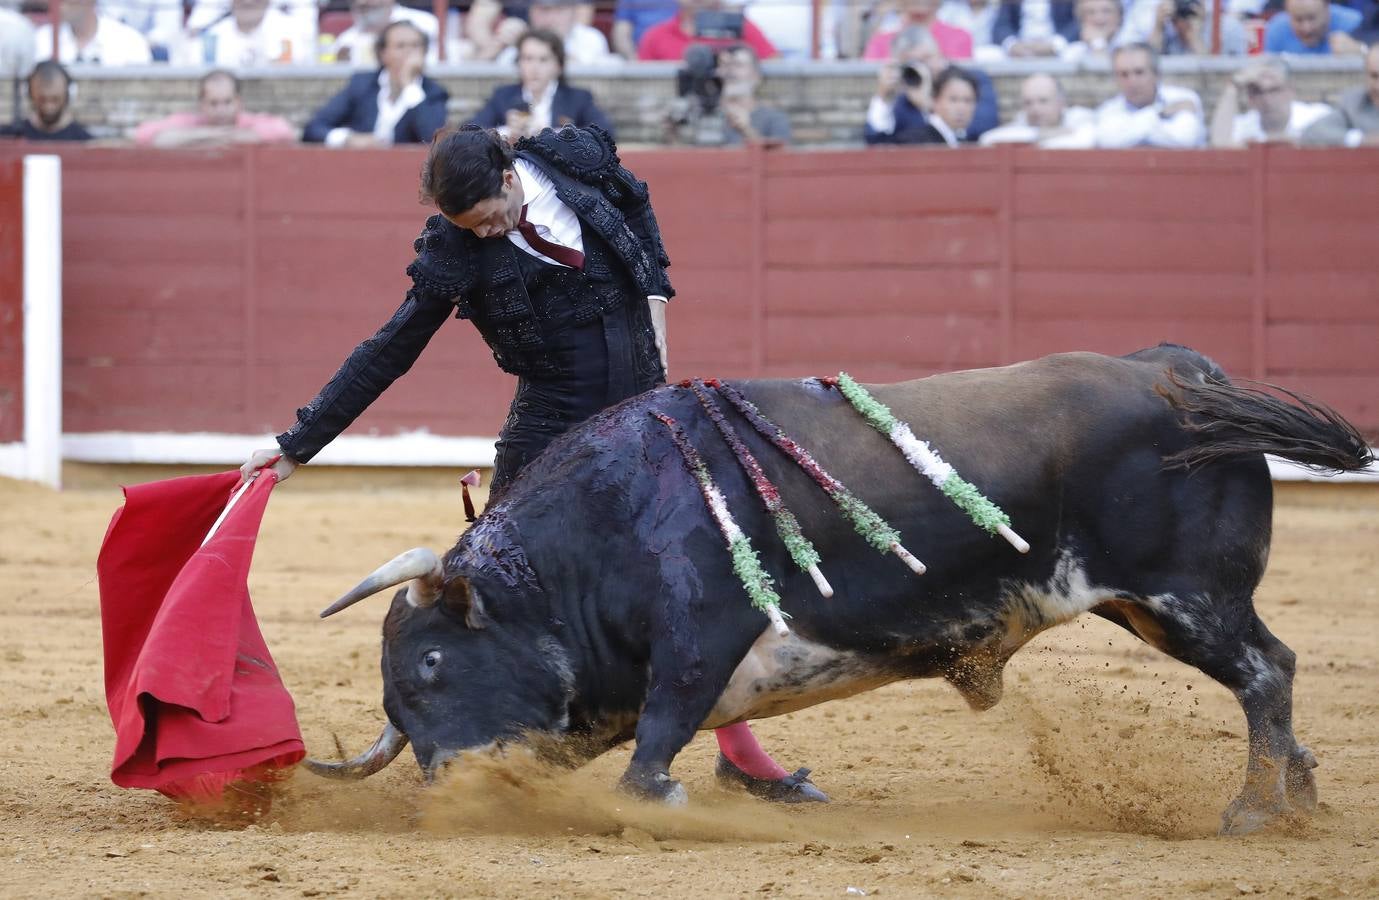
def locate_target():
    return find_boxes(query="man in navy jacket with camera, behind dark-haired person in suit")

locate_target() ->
[862,28,998,143]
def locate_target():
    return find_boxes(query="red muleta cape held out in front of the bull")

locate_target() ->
[97,470,306,802]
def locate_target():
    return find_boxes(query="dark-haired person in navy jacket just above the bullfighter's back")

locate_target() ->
[470,30,612,141]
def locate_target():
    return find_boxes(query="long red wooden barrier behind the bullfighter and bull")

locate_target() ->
[2,147,1379,436]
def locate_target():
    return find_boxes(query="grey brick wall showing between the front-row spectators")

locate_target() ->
[0,58,1364,145]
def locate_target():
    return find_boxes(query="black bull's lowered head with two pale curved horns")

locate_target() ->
[306,549,572,780]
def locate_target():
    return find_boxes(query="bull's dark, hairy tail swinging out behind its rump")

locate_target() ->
[1156,372,1375,471]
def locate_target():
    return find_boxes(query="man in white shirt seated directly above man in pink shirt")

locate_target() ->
[177,0,316,69]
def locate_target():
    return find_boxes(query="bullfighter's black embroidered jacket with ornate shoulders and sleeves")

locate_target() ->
[277,127,674,462]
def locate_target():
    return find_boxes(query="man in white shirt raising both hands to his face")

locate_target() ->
[1211,58,1331,147]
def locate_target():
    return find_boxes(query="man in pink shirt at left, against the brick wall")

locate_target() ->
[134,69,296,147]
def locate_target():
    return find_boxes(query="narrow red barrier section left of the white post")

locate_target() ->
[0,157,23,444]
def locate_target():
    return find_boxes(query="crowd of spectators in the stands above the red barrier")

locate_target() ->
[0,0,1379,147]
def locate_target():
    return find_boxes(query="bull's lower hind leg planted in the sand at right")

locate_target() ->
[1096,595,1317,834]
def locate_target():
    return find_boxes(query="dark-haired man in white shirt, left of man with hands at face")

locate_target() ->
[1096,44,1202,147]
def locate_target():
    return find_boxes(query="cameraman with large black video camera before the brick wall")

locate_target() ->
[667,44,792,147]
